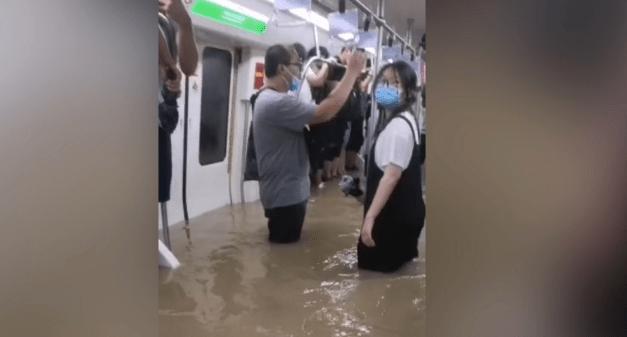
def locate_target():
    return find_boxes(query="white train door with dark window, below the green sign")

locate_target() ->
[168,41,237,224]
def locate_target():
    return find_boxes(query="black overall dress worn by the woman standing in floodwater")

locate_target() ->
[357,116,425,272]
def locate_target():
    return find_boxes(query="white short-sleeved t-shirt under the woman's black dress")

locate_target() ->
[374,111,420,171]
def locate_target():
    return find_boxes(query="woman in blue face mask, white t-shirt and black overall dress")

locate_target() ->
[357,61,425,272]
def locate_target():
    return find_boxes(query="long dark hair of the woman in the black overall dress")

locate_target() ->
[373,61,418,134]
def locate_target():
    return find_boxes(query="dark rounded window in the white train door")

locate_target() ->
[199,47,233,166]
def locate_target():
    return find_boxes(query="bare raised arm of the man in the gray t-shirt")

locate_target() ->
[310,52,366,124]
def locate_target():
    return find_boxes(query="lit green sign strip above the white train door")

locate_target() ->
[192,0,268,35]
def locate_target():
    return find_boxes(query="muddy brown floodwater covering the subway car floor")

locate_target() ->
[159,188,425,337]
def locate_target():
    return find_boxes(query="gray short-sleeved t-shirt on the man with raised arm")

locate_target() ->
[253,89,316,209]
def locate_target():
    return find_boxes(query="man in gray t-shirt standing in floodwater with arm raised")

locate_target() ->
[253,45,366,243]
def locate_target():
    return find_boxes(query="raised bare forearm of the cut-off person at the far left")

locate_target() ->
[168,0,198,76]
